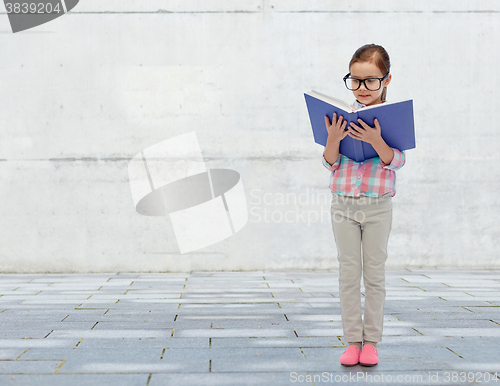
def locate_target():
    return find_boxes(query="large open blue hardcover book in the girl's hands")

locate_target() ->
[304,91,416,162]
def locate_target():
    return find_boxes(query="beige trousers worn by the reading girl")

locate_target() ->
[331,192,392,342]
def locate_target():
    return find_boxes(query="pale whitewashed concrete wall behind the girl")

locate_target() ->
[0,0,500,272]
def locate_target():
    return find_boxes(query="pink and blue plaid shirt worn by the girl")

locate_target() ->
[323,101,406,197]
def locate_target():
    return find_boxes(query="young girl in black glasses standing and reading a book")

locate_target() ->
[323,44,406,366]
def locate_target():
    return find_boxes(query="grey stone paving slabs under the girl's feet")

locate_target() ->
[0,269,500,386]
